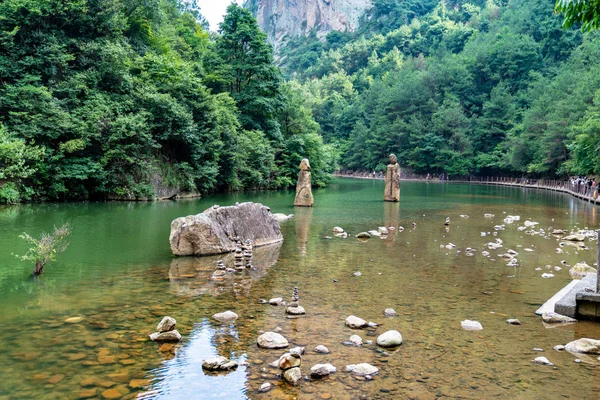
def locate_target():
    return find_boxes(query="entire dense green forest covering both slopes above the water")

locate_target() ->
[0,0,600,203]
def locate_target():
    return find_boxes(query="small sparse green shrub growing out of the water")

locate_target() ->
[17,223,72,276]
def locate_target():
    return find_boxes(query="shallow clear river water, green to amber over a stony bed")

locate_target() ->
[0,179,600,399]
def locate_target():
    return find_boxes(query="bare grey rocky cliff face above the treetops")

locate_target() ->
[245,0,373,49]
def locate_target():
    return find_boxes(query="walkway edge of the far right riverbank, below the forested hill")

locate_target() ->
[333,173,600,204]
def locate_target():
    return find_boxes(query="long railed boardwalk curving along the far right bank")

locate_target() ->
[334,172,600,204]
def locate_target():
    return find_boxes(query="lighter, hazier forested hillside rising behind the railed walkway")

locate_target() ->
[279,0,600,176]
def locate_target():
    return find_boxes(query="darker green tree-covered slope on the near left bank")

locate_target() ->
[0,0,336,203]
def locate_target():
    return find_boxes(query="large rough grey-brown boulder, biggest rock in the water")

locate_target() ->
[169,203,283,256]
